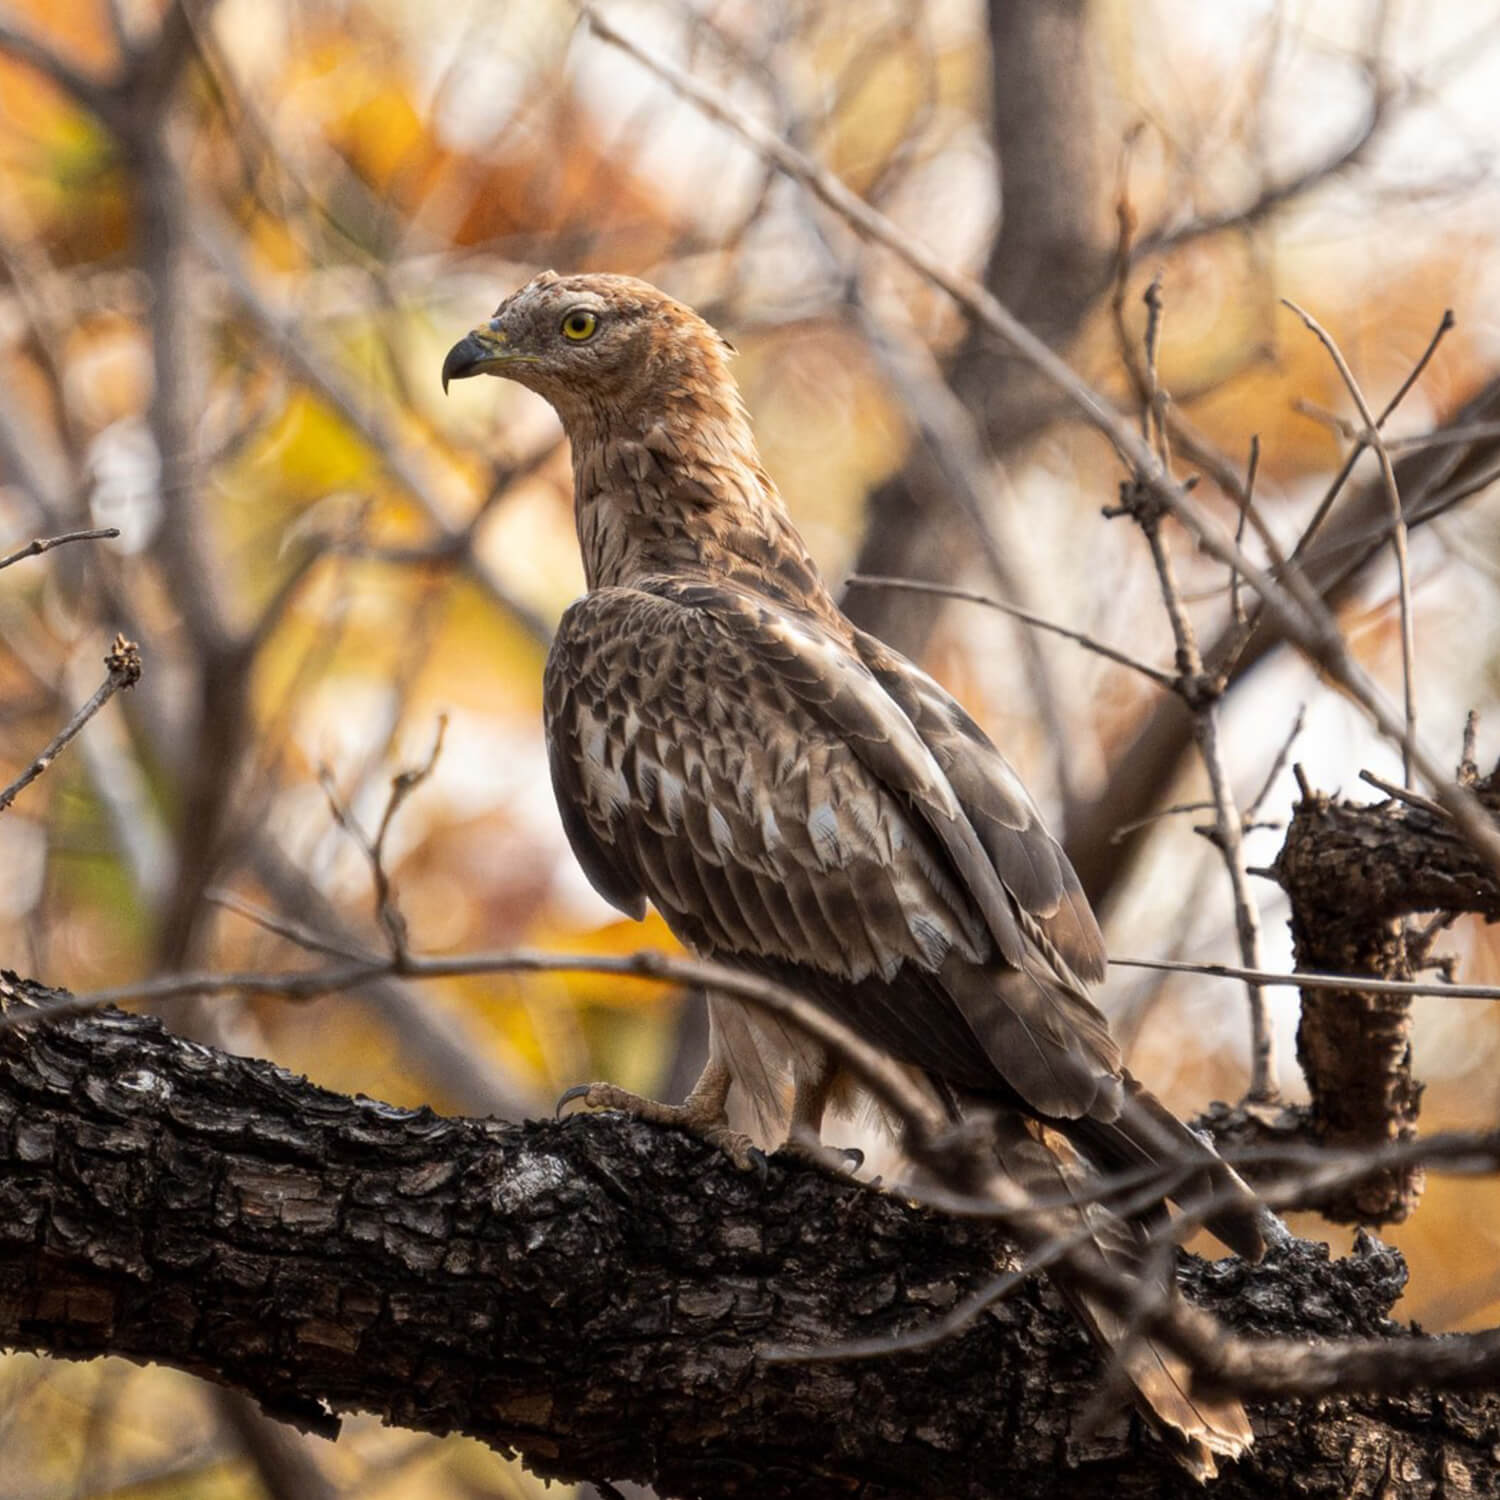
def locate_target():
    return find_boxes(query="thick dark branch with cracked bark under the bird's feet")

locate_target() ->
[0,978,1500,1500]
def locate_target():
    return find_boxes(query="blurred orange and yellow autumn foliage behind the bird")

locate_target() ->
[0,0,1500,1500]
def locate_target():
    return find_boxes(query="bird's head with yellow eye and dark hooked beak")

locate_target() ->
[443,272,731,426]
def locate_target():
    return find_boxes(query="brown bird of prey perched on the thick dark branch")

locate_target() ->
[443,272,1263,1476]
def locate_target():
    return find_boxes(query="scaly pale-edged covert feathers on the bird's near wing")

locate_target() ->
[545,590,984,980]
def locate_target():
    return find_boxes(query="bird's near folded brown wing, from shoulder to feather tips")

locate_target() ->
[546,582,1119,1118]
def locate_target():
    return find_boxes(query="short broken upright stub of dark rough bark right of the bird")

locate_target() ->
[1275,777,1500,1224]
